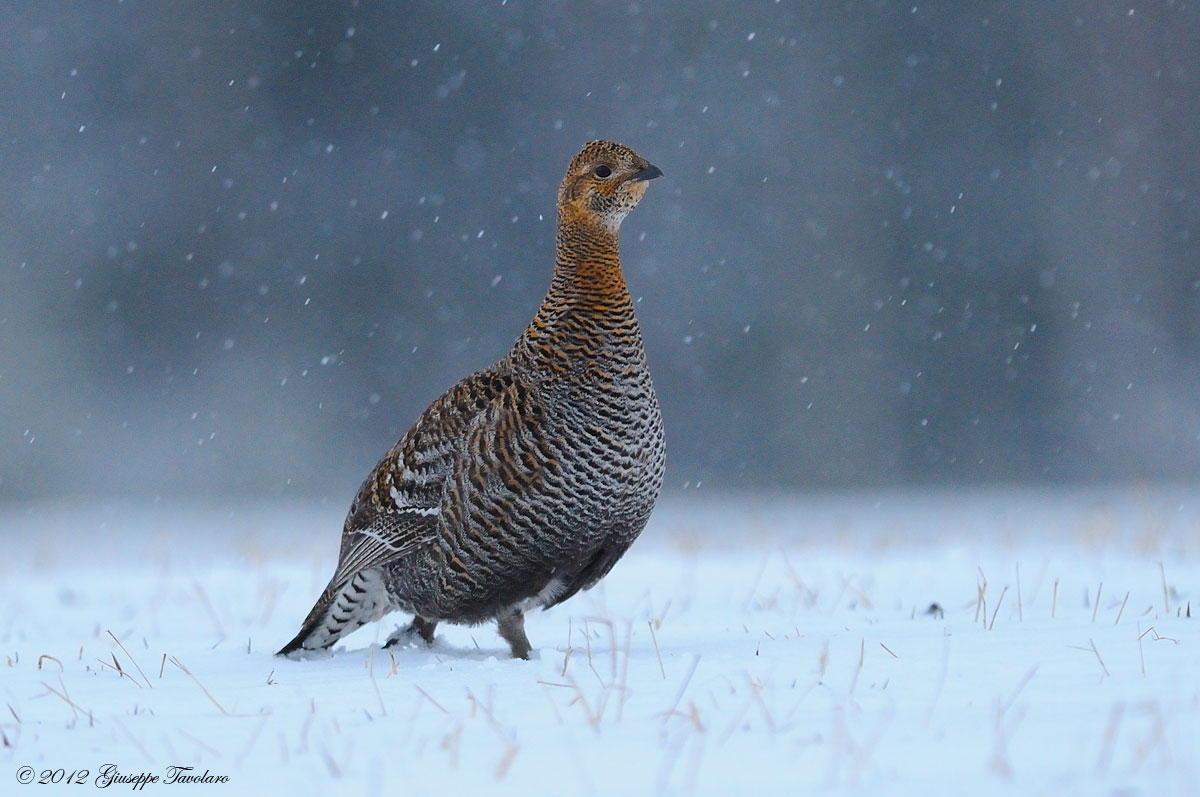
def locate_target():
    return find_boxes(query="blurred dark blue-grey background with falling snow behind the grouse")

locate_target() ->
[0,0,1200,502]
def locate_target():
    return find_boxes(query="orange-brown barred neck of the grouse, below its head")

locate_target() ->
[517,218,640,370]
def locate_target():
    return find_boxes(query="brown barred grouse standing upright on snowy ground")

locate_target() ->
[277,140,666,659]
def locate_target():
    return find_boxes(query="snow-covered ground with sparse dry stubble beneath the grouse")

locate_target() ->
[0,489,1200,795]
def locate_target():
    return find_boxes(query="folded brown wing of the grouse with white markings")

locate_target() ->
[321,370,532,588]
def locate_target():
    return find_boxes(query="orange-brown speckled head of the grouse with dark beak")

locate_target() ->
[558,142,662,233]
